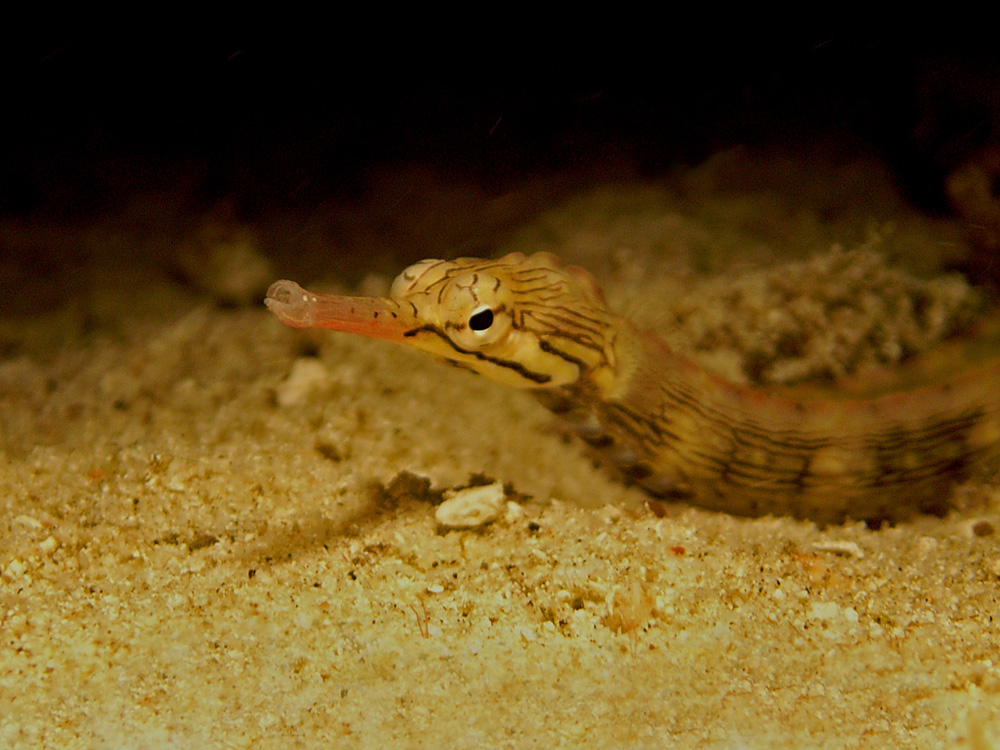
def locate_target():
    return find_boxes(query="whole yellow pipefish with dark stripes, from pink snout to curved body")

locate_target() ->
[265,253,1000,523]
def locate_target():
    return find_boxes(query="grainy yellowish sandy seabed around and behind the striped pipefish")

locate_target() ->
[0,150,1000,748]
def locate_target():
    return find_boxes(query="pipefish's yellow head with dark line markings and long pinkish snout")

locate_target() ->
[266,253,615,388]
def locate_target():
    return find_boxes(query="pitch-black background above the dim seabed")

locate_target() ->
[0,27,1000,223]
